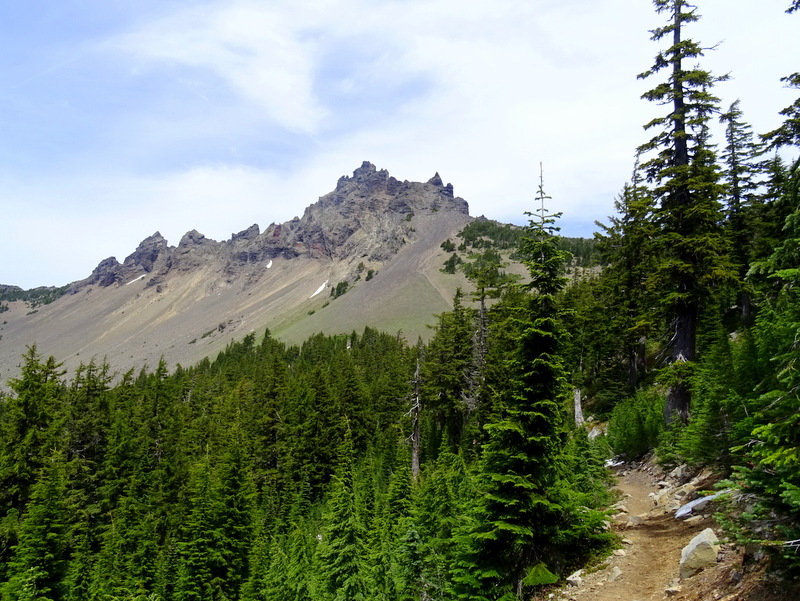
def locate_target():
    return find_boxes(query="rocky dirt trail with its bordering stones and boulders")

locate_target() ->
[542,464,800,601]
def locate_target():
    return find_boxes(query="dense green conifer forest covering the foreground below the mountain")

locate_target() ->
[0,0,800,601]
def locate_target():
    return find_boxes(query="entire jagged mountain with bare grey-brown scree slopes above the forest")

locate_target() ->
[0,162,471,382]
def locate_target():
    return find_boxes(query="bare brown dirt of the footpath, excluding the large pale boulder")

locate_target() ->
[541,466,800,601]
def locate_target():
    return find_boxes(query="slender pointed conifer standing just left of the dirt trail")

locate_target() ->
[458,168,568,599]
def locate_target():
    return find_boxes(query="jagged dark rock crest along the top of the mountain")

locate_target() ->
[75,161,469,290]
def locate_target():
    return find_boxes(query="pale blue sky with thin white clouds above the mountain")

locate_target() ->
[0,0,800,288]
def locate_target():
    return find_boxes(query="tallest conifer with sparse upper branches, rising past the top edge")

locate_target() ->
[639,0,733,421]
